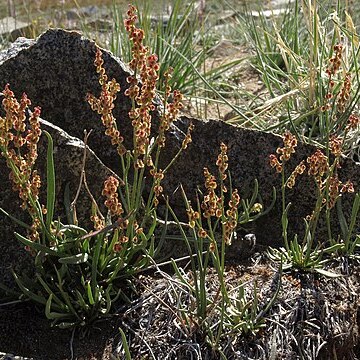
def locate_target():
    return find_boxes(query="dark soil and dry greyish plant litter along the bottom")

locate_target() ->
[0,253,360,360]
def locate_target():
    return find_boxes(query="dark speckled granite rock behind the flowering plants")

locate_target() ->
[0,30,360,278]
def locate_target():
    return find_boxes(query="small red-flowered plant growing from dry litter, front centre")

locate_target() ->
[168,143,277,351]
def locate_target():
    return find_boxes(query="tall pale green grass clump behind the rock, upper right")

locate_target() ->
[238,0,360,150]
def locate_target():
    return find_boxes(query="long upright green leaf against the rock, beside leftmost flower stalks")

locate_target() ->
[44,131,55,229]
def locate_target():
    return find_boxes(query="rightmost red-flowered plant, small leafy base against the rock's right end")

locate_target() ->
[269,111,360,276]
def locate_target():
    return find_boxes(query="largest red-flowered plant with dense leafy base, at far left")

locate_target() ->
[0,6,192,328]
